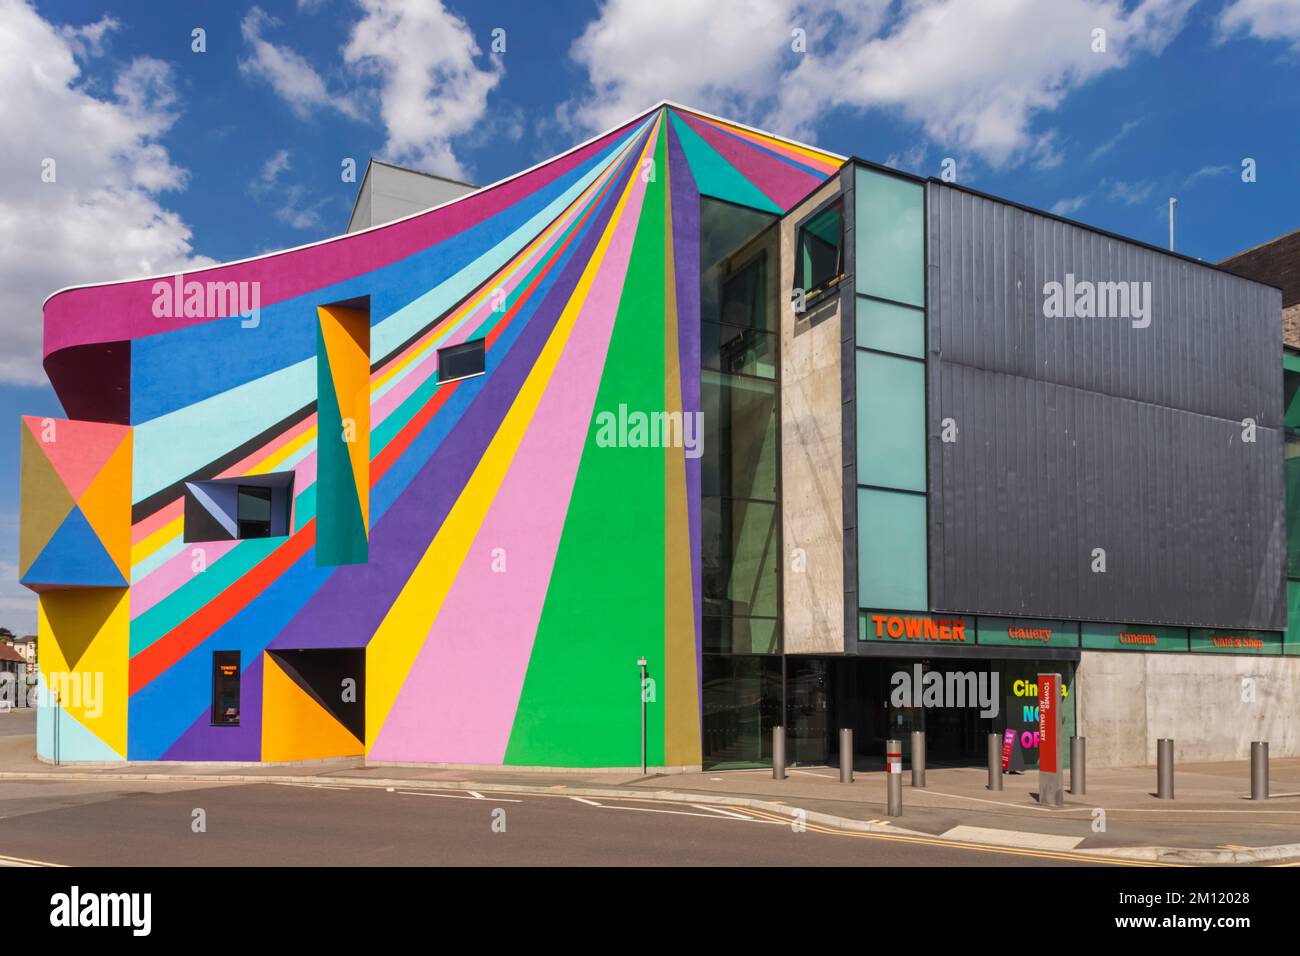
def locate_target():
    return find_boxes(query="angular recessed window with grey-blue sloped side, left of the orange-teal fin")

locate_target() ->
[183,471,294,541]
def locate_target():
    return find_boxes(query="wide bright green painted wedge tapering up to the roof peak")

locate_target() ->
[506,128,667,766]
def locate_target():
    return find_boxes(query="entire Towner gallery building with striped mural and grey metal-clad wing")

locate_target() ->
[20,103,1300,767]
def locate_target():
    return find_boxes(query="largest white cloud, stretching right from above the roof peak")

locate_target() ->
[562,0,1193,166]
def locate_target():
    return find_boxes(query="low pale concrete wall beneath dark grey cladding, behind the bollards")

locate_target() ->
[1075,650,1300,764]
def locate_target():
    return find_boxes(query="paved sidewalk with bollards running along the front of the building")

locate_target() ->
[0,718,1300,864]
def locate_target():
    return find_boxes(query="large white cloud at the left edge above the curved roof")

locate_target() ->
[0,0,212,384]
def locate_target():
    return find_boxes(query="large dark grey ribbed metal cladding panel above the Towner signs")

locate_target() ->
[927,182,1286,630]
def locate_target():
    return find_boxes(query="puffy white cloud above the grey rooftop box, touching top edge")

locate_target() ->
[343,0,504,179]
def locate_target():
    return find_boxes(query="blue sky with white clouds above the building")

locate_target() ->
[0,0,1300,632]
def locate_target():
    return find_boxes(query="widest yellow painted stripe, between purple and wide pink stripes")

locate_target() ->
[365,121,658,752]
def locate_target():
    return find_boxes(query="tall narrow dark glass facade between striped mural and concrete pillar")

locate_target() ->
[699,198,781,766]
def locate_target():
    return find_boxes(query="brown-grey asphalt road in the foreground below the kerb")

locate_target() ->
[0,780,1118,866]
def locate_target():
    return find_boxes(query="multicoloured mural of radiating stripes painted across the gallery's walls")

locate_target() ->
[23,104,842,766]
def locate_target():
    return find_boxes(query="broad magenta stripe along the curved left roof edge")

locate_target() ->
[44,117,640,356]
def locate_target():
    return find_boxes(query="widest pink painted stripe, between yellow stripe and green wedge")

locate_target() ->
[371,121,658,763]
